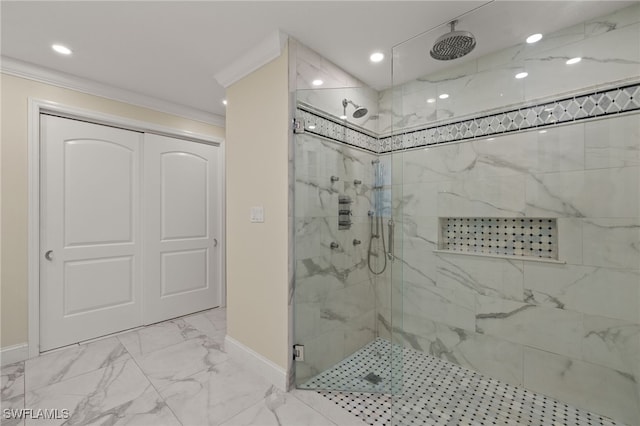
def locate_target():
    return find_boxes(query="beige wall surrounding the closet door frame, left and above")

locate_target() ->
[0,74,224,348]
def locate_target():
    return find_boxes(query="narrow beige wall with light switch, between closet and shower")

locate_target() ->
[226,50,289,369]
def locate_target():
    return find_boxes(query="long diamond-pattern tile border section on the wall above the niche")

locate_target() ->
[378,84,640,153]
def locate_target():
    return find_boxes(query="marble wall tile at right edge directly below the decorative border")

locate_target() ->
[584,113,640,169]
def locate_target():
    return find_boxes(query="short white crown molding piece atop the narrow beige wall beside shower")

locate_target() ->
[214,30,289,89]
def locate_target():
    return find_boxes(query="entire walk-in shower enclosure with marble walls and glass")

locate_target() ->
[294,2,640,425]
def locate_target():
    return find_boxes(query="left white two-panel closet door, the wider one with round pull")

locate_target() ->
[40,115,143,351]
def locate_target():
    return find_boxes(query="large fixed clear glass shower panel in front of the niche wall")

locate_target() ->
[390,2,640,425]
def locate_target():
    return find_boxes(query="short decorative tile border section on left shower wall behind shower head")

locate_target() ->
[296,106,380,154]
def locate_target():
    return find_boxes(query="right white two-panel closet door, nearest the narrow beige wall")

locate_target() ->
[143,134,222,324]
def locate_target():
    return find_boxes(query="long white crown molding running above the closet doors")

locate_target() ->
[0,56,225,127]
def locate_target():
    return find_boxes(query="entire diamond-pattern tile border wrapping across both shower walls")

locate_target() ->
[296,83,640,154]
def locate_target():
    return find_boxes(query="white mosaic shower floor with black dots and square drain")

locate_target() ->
[300,338,621,426]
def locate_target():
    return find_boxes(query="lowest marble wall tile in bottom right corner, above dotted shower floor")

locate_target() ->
[524,348,640,425]
